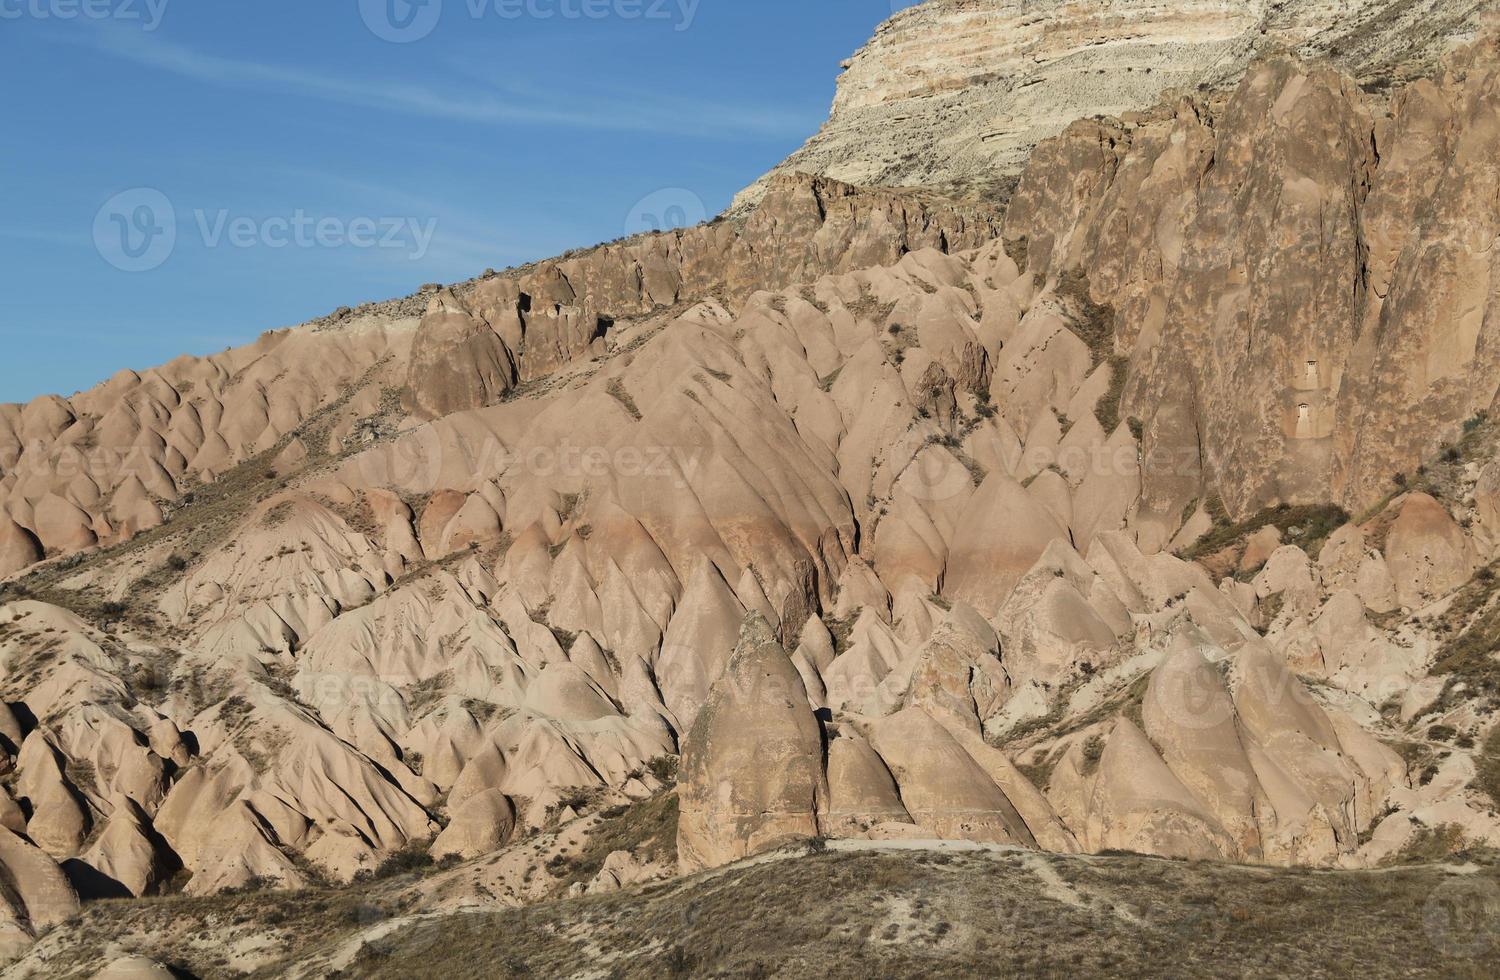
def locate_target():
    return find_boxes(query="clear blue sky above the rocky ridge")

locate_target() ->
[0,0,906,402]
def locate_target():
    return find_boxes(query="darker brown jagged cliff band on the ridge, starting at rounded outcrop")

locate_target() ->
[407,174,999,419]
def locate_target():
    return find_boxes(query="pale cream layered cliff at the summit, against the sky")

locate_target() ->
[737,0,1494,209]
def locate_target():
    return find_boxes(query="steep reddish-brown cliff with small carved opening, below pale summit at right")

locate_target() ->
[1007,30,1500,519]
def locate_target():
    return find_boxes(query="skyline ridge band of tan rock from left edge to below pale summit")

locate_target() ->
[0,174,1001,578]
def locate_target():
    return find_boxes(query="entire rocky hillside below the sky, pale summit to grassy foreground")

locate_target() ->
[0,0,1500,975]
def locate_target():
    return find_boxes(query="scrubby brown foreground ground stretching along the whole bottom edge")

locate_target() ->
[20,840,1500,977]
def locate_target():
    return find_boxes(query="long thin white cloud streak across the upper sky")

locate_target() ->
[74,30,807,138]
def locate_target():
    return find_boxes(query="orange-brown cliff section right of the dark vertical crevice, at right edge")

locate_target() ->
[1337,38,1500,500]
